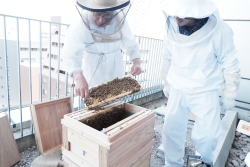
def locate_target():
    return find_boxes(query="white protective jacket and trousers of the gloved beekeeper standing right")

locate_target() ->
[163,12,239,167]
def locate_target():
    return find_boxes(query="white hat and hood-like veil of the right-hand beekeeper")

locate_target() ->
[159,0,217,46]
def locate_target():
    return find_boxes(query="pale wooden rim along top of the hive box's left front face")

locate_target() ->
[61,119,111,149]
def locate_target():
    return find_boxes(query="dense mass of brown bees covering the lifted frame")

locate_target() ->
[84,77,141,106]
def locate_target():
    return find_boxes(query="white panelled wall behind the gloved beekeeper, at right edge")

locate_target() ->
[215,0,250,109]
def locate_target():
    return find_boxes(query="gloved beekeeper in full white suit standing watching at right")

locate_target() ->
[160,0,240,167]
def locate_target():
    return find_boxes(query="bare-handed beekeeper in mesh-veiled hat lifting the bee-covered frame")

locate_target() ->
[63,0,141,98]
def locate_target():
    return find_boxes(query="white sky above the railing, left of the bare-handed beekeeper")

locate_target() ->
[0,0,77,21]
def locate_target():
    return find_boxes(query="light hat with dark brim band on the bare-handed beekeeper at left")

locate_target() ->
[76,0,130,12]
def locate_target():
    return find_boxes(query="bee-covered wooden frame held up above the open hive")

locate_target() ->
[85,76,141,109]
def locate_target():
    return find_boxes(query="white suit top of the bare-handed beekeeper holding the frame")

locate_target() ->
[63,16,141,88]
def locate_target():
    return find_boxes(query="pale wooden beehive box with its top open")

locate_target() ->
[61,102,155,167]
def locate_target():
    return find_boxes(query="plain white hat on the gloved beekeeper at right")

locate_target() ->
[159,0,217,18]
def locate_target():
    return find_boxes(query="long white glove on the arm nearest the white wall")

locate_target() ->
[221,70,241,114]
